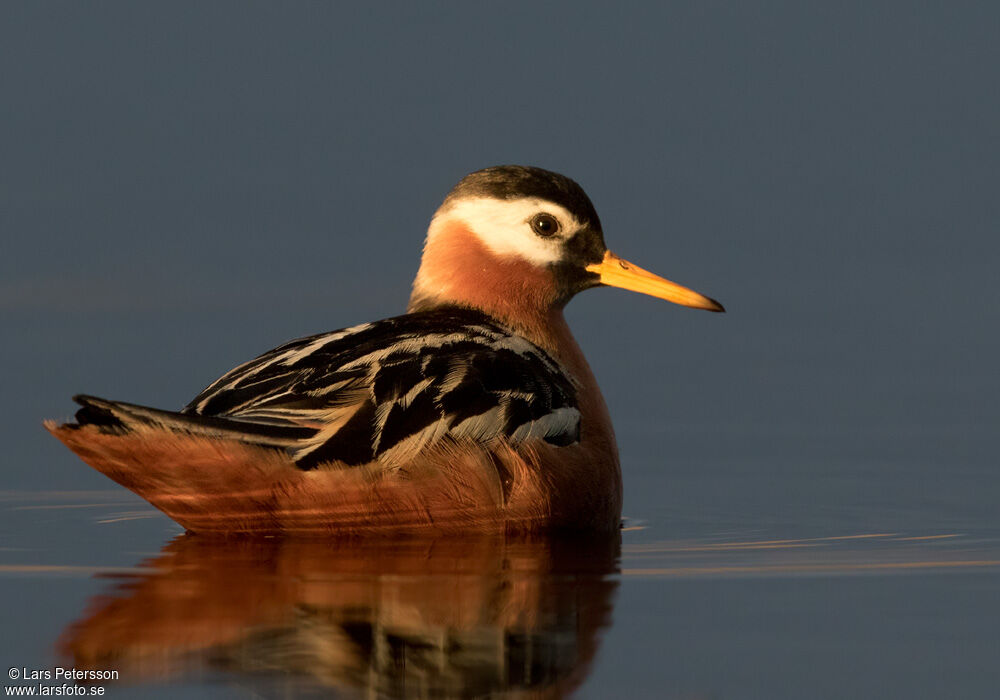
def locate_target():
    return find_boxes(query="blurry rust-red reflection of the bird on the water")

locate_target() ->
[59,534,620,697]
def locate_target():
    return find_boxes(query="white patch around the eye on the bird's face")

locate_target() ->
[431,197,580,265]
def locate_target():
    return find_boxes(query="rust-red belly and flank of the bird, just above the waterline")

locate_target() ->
[46,423,618,537]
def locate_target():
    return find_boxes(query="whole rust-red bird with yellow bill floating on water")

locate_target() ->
[45,166,724,535]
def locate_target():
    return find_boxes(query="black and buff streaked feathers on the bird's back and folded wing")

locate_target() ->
[183,307,580,469]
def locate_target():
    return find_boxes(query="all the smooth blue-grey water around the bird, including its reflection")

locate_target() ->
[0,2,1000,699]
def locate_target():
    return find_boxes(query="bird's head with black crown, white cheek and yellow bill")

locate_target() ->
[410,165,724,323]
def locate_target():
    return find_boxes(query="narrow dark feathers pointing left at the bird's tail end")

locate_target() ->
[68,394,316,448]
